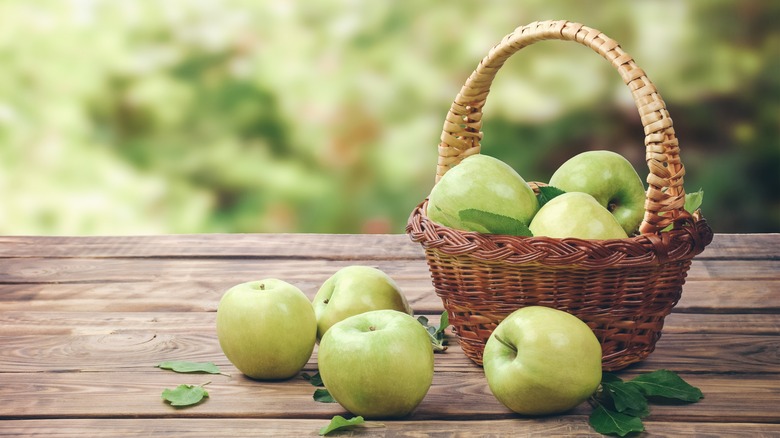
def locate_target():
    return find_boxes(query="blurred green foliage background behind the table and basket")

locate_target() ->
[0,0,780,235]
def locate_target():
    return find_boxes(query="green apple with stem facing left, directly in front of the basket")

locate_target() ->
[482,306,601,415]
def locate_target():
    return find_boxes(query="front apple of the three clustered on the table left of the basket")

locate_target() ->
[317,310,433,418]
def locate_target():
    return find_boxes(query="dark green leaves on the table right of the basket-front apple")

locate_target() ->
[588,369,703,437]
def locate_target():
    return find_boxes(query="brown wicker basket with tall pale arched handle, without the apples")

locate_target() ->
[406,21,712,370]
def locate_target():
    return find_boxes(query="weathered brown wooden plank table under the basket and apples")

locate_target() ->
[0,234,780,438]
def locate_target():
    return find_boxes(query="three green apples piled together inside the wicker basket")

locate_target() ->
[426,150,645,240]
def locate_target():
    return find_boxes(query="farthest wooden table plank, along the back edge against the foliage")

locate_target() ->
[0,233,780,260]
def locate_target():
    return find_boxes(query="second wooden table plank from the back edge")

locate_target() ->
[0,258,780,283]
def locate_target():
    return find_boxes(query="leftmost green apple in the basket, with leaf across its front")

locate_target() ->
[426,154,539,235]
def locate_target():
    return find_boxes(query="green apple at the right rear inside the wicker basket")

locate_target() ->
[549,151,645,235]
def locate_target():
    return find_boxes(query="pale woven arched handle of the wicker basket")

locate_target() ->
[436,20,690,234]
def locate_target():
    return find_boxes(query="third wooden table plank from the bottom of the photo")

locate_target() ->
[0,326,780,373]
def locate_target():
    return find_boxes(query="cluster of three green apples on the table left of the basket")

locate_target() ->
[216,265,433,418]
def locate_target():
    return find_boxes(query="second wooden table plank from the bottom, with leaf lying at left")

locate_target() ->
[0,370,780,422]
